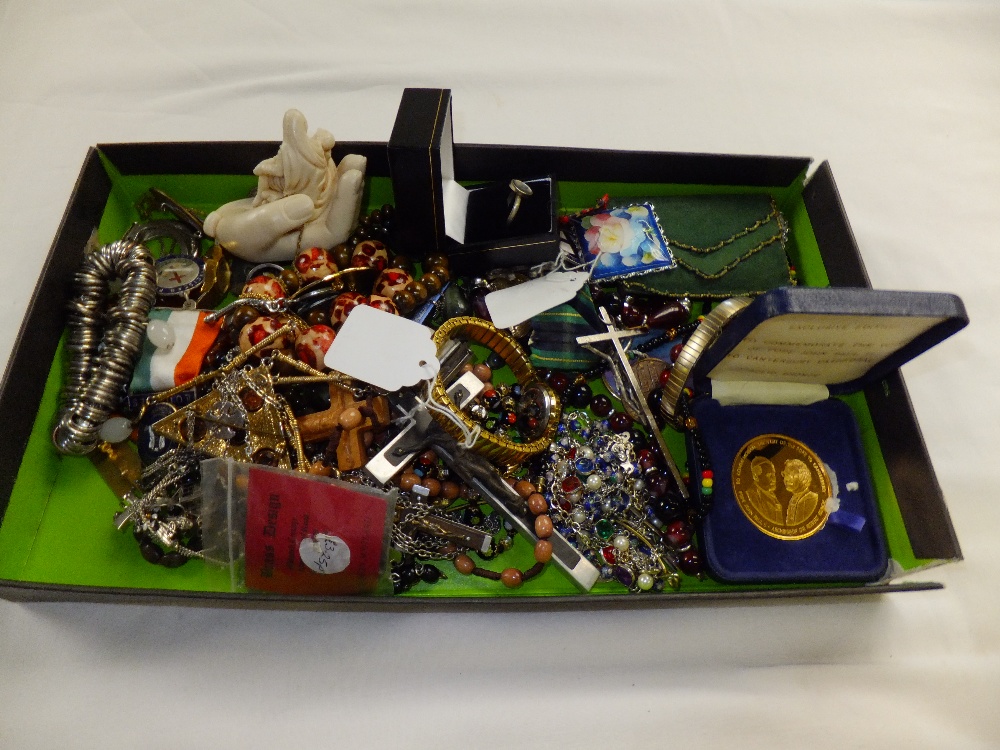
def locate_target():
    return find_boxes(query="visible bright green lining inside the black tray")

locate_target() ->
[0,158,930,597]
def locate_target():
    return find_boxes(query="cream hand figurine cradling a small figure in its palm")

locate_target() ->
[205,109,367,263]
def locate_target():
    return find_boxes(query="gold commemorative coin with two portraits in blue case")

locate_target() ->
[733,434,830,540]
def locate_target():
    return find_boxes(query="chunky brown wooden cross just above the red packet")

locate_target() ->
[296,383,389,471]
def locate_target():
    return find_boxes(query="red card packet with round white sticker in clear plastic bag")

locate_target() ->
[202,459,396,595]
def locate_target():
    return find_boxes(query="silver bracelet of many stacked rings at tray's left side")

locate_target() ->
[52,240,156,456]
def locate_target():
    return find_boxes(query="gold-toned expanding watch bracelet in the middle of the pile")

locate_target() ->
[431,316,562,467]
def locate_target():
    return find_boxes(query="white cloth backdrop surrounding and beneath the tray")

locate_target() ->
[0,0,1000,750]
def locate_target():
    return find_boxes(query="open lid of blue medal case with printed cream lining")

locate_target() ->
[694,287,969,393]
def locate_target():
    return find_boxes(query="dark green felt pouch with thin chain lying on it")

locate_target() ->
[612,194,792,299]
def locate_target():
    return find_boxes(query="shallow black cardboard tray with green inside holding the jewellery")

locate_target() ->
[0,142,961,610]
